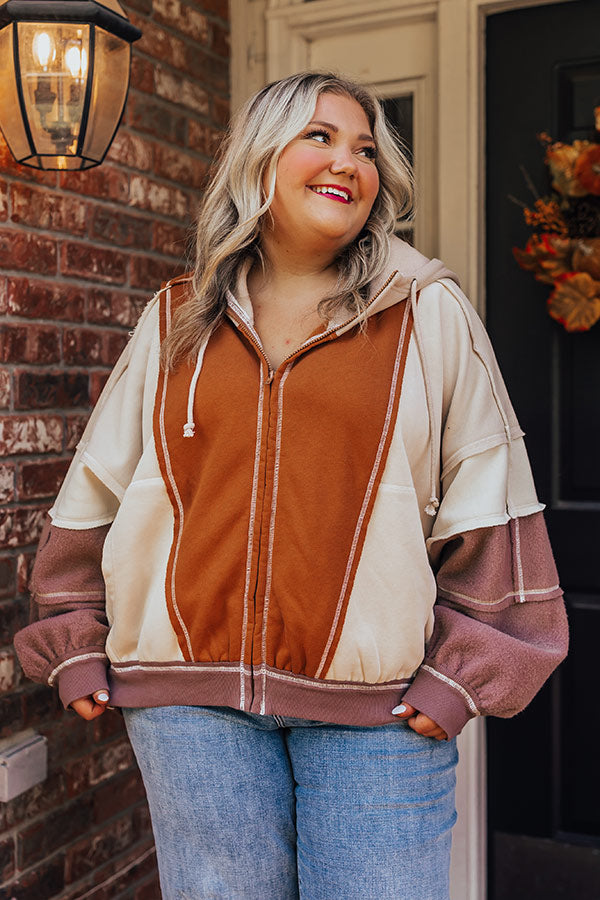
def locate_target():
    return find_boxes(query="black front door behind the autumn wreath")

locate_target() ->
[486,0,600,900]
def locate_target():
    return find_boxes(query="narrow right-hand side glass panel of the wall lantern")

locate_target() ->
[82,28,131,162]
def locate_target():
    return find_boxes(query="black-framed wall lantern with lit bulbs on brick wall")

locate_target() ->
[0,0,142,170]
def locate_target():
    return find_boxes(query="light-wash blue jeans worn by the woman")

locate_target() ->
[123,706,457,900]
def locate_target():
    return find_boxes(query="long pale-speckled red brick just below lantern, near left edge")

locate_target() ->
[10,183,88,234]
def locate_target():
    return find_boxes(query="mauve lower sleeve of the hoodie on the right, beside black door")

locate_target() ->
[404,513,568,737]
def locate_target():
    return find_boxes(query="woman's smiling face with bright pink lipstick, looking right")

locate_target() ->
[270,94,379,250]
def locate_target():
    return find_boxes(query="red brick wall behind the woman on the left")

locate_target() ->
[0,0,229,900]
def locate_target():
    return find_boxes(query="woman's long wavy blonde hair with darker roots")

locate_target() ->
[162,72,413,368]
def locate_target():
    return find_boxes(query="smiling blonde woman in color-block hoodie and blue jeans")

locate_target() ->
[17,74,566,900]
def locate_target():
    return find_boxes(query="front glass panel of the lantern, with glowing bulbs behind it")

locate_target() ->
[17,22,90,169]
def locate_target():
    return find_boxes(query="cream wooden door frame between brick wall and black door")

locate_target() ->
[230,0,572,900]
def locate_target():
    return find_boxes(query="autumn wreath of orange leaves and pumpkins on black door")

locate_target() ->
[513,106,600,331]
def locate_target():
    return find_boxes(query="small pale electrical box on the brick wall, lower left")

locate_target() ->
[0,728,48,803]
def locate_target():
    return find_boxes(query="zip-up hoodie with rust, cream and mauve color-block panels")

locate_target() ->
[15,239,567,737]
